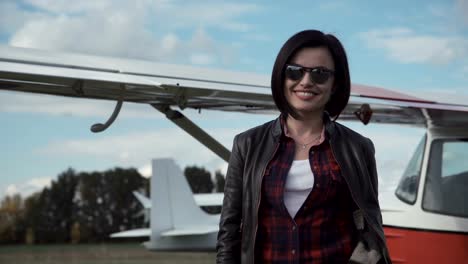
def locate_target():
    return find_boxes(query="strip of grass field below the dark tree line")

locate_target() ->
[0,243,215,264]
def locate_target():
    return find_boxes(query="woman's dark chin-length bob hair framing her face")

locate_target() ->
[271,30,351,119]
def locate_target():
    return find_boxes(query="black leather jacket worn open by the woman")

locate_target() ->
[217,117,391,263]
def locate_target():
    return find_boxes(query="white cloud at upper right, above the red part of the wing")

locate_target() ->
[360,28,468,64]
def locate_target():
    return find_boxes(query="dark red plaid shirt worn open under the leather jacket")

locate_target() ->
[255,119,356,263]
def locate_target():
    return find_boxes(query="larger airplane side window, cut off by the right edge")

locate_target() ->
[423,139,468,217]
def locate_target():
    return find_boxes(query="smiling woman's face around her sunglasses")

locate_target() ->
[284,47,335,117]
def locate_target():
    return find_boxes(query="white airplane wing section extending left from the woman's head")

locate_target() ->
[0,46,274,111]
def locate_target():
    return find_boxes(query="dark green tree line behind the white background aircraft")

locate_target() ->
[0,166,224,244]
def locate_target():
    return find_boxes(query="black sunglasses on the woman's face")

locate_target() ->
[284,64,335,84]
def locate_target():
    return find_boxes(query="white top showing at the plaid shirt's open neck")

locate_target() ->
[283,159,314,218]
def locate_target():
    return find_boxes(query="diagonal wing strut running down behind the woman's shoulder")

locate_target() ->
[151,104,231,162]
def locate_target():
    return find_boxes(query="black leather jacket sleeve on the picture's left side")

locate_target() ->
[216,136,244,263]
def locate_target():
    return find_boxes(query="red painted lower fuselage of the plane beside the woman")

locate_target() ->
[384,227,468,264]
